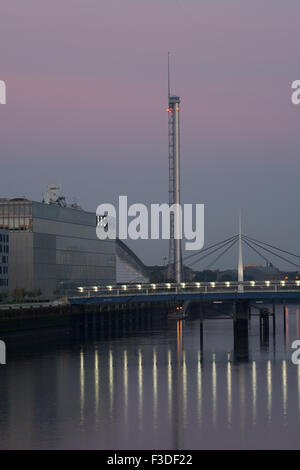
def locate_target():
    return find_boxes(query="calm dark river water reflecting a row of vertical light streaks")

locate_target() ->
[0,305,300,449]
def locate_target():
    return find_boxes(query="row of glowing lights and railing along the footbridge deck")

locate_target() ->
[73,280,300,297]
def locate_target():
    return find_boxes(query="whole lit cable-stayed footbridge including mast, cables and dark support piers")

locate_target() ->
[68,223,300,360]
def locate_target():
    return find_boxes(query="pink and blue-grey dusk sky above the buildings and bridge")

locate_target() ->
[0,0,300,268]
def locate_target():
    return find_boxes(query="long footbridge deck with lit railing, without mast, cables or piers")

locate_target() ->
[69,280,300,305]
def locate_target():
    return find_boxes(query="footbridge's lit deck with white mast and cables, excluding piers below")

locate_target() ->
[69,221,300,310]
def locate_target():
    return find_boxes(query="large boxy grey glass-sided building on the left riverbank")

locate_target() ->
[0,199,116,299]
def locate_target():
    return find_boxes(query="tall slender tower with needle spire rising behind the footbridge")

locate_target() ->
[168,53,183,283]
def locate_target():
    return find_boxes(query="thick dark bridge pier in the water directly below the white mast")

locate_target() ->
[233,301,249,362]
